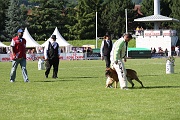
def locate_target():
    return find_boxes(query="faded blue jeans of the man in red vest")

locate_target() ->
[10,58,28,82]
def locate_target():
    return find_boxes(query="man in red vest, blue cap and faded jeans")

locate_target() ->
[10,29,29,82]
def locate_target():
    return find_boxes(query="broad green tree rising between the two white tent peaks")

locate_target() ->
[28,0,66,40]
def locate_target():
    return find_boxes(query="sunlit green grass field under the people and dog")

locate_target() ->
[0,58,180,120]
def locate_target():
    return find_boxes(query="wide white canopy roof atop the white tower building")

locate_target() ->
[134,14,179,22]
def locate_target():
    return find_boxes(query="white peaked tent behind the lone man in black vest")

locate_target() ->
[41,27,72,53]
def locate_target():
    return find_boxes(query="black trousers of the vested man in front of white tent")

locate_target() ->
[45,58,59,78]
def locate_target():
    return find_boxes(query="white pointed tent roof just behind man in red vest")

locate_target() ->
[23,28,40,47]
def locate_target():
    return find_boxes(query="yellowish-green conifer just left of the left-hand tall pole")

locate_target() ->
[66,0,103,39]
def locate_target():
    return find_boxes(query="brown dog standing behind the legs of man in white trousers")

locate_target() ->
[105,68,144,88]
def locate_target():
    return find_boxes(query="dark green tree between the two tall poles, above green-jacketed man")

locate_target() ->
[101,0,134,36]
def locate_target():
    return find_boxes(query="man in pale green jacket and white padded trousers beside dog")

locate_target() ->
[111,34,132,89]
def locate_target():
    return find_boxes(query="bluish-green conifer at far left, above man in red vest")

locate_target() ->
[5,0,27,40]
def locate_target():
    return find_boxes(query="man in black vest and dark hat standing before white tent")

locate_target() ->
[44,35,61,78]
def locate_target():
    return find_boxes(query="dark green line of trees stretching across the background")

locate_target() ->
[0,0,180,41]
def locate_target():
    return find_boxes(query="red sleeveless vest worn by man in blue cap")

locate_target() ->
[12,36,26,58]
